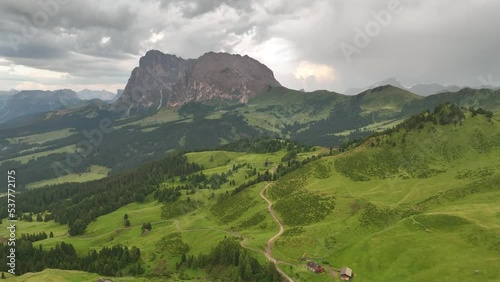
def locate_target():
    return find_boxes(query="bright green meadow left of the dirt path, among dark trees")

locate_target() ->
[0,145,317,281]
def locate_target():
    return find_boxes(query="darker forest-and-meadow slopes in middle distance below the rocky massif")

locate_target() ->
[0,86,500,189]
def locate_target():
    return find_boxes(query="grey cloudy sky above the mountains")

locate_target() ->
[0,0,500,92]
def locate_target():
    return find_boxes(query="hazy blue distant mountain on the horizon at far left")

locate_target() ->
[0,89,80,123]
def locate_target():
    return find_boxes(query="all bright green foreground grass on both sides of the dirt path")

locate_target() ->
[0,117,500,281]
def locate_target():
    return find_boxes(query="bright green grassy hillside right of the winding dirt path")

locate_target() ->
[270,107,500,281]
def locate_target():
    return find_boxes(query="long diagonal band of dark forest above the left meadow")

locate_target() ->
[0,152,200,236]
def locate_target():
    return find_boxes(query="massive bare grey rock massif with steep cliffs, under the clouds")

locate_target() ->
[113,50,281,112]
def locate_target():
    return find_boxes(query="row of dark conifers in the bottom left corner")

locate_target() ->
[0,237,141,276]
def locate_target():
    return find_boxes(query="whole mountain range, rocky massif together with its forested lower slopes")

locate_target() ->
[0,50,500,186]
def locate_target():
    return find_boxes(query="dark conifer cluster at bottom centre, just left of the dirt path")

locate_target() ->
[177,238,281,282]
